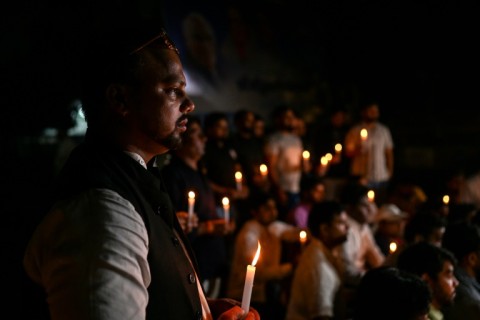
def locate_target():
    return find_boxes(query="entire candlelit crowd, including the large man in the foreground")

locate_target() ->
[24,20,480,320]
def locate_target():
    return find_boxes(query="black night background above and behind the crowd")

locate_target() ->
[0,0,480,316]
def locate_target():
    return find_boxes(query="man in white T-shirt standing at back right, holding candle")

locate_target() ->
[345,102,394,205]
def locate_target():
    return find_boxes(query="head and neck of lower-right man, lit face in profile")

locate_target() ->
[398,242,463,320]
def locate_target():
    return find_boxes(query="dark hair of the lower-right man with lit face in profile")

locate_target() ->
[397,241,457,280]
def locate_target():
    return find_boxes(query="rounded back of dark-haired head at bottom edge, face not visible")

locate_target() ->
[353,267,432,320]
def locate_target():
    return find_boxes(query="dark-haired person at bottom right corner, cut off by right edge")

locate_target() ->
[444,222,480,320]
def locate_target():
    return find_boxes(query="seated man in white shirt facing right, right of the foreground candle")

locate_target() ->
[285,201,348,320]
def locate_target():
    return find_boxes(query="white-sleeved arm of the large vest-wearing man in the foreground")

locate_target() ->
[24,189,150,320]
